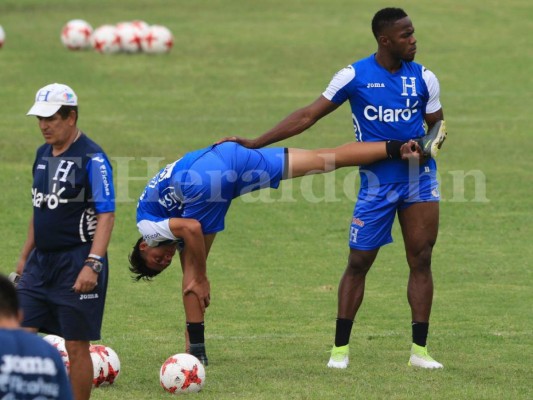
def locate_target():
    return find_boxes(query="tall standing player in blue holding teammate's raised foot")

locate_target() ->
[216,8,446,368]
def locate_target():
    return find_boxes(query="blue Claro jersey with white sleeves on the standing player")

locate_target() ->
[323,54,441,187]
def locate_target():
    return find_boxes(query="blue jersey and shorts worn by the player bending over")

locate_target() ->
[137,142,287,247]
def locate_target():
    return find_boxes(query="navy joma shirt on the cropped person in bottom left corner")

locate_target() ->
[0,329,73,400]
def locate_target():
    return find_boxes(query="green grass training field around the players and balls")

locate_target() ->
[0,0,533,400]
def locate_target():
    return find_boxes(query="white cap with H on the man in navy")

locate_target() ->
[26,83,78,117]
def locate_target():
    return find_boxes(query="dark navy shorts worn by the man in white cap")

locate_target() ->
[17,243,108,341]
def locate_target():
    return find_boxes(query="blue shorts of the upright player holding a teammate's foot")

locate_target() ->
[348,176,440,250]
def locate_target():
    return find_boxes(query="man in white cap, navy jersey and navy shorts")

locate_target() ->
[16,83,115,400]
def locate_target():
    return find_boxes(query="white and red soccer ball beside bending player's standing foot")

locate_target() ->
[159,353,205,394]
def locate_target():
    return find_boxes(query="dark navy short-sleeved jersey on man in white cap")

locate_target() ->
[32,134,115,251]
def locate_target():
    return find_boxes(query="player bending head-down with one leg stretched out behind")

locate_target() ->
[129,132,436,365]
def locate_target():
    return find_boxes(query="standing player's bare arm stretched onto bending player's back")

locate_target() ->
[217,95,338,149]
